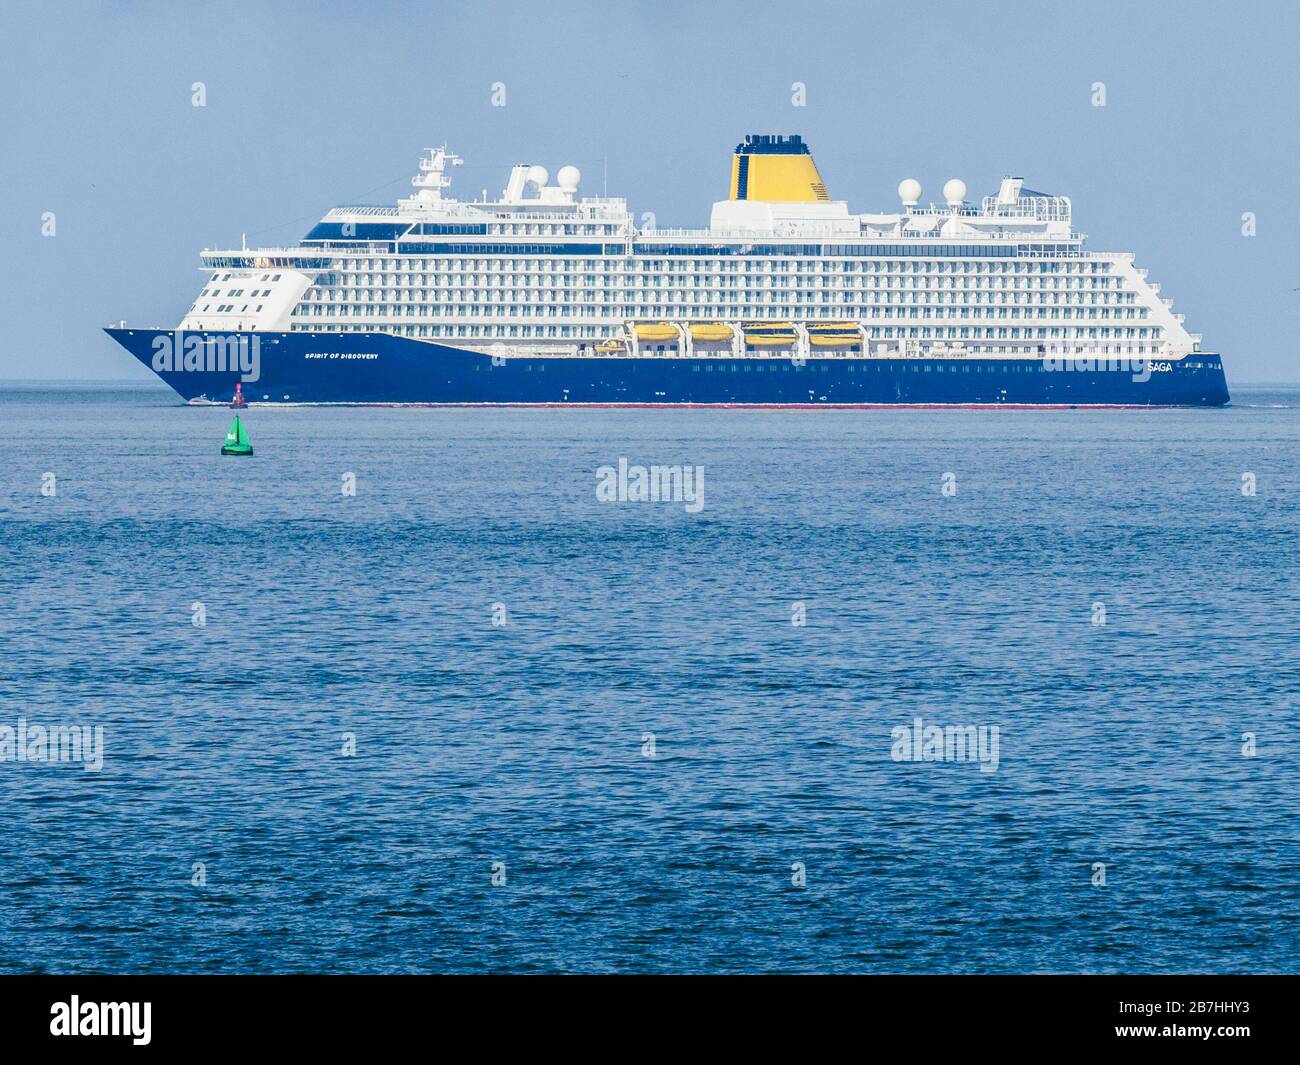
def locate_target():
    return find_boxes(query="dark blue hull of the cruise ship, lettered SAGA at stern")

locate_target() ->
[105,328,1229,407]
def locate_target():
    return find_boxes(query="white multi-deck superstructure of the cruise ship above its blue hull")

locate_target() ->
[181,138,1200,358]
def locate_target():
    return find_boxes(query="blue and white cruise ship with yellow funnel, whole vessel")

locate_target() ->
[107,134,1229,407]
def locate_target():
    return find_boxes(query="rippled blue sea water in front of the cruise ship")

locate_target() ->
[0,385,1300,973]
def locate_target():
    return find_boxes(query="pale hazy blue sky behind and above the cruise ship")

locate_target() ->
[0,0,1300,384]
